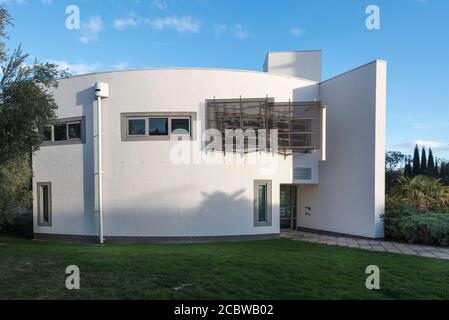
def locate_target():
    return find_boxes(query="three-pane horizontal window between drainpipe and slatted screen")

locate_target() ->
[120,112,197,141]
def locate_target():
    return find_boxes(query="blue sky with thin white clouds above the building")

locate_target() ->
[0,0,449,159]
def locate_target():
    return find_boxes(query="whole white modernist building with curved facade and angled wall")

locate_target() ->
[33,51,386,242]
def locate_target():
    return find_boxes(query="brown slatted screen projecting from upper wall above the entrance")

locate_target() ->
[206,98,325,154]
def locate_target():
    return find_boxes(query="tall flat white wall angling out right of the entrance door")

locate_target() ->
[298,61,386,238]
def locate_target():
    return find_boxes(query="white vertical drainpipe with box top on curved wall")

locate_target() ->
[95,82,109,244]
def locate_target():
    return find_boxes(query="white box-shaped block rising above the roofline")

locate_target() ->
[264,50,321,81]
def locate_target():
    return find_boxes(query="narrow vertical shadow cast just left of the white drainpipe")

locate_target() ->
[76,86,98,234]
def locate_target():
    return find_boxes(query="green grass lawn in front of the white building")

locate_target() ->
[0,238,449,299]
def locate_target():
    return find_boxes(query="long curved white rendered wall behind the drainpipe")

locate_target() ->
[33,69,319,238]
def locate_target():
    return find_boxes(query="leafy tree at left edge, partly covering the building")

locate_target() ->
[0,7,68,225]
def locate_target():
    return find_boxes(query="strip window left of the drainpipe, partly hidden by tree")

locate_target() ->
[42,117,86,147]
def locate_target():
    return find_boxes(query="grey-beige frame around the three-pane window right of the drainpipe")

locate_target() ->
[120,112,197,142]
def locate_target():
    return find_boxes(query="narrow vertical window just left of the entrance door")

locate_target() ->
[254,180,271,227]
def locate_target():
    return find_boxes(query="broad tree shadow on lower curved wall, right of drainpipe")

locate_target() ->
[100,187,256,237]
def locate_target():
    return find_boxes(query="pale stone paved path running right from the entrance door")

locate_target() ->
[281,231,449,260]
